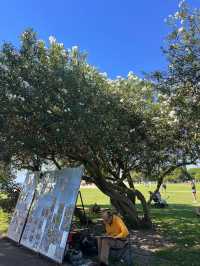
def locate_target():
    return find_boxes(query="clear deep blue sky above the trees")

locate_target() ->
[0,0,200,183]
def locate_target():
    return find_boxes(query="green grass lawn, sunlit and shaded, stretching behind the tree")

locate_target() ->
[0,184,200,266]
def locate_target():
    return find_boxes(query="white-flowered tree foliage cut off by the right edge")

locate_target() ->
[154,1,200,170]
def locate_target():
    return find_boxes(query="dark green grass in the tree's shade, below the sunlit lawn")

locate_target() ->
[79,204,200,266]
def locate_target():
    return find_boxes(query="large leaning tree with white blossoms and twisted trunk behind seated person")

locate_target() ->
[0,30,191,229]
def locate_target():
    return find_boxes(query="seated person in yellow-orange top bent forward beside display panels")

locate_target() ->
[97,211,129,266]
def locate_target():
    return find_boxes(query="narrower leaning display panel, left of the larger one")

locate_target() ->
[8,173,36,243]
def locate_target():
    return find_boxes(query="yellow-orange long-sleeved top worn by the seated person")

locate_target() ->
[106,215,129,238]
